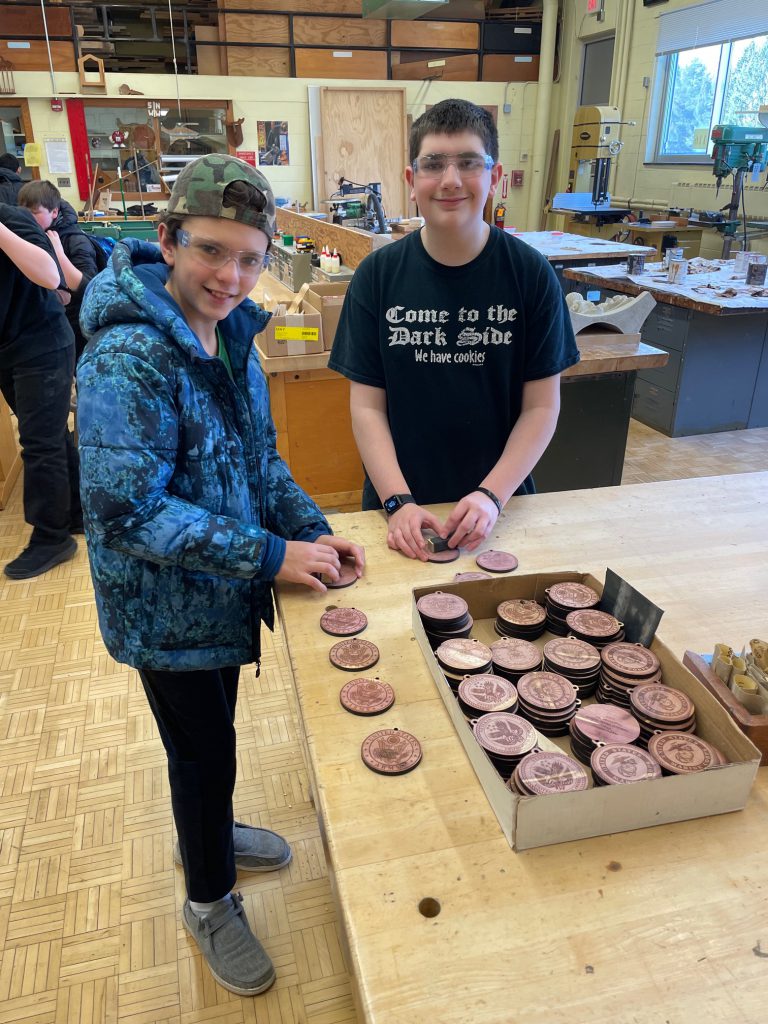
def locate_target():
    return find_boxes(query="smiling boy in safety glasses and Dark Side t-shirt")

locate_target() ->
[329,99,579,560]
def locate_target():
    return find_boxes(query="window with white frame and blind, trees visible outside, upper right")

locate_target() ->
[647,0,768,164]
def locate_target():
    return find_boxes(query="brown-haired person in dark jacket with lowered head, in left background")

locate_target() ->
[17,181,99,360]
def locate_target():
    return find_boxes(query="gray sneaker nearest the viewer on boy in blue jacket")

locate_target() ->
[181,893,275,995]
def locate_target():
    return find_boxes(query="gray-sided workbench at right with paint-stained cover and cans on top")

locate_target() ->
[565,263,768,437]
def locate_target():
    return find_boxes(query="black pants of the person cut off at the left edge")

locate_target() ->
[0,344,82,544]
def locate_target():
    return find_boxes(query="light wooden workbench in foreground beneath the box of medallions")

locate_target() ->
[280,473,768,1024]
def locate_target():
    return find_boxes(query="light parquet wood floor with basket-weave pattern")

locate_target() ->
[0,421,768,1024]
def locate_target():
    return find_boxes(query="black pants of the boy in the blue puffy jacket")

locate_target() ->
[139,667,240,903]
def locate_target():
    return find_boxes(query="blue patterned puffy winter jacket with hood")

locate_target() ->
[77,239,330,672]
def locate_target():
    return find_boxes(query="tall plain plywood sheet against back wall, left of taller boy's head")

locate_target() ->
[319,88,408,217]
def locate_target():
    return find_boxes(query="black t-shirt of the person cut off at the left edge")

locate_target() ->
[0,203,75,367]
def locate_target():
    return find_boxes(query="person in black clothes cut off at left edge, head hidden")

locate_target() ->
[0,203,82,580]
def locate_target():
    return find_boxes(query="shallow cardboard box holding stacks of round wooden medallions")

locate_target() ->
[413,571,760,851]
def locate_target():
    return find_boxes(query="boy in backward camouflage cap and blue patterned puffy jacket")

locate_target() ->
[78,155,365,995]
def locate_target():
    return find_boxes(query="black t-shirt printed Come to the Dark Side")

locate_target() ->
[329,227,579,504]
